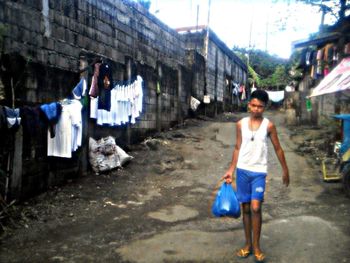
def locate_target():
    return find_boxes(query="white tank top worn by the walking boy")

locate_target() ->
[237,117,269,173]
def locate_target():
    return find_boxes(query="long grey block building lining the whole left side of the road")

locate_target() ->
[0,0,247,199]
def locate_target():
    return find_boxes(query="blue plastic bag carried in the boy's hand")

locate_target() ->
[211,182,241,218]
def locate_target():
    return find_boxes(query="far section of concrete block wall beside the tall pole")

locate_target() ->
[183,30,247,115]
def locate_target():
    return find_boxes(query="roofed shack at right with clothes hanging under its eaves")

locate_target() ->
[293,18,350,124]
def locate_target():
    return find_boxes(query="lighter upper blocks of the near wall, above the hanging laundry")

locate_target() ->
[0,0,185,72]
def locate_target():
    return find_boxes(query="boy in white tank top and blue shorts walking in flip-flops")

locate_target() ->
[223,90,289,262]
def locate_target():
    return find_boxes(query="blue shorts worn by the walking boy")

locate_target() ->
[236,168,267,203]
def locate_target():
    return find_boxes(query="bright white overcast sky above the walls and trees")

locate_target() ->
[150,0,321,58]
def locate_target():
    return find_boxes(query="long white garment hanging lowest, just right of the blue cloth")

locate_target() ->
[47,99,82,158]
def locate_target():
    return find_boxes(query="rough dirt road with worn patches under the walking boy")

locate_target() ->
[0,113,350,263]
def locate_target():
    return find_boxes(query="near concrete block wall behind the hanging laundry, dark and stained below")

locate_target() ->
[0,0,192,198]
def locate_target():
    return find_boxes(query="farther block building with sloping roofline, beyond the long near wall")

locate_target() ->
[177,26,248,116]
